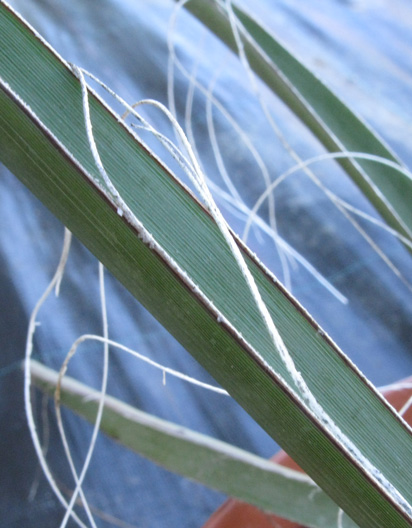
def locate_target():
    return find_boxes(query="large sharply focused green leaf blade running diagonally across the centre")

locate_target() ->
[0,3,412,528]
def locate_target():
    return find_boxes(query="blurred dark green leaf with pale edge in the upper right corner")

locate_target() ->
[185,0,412,245]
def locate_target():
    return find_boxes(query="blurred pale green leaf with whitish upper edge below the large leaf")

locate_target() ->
[31,361,355,528]
